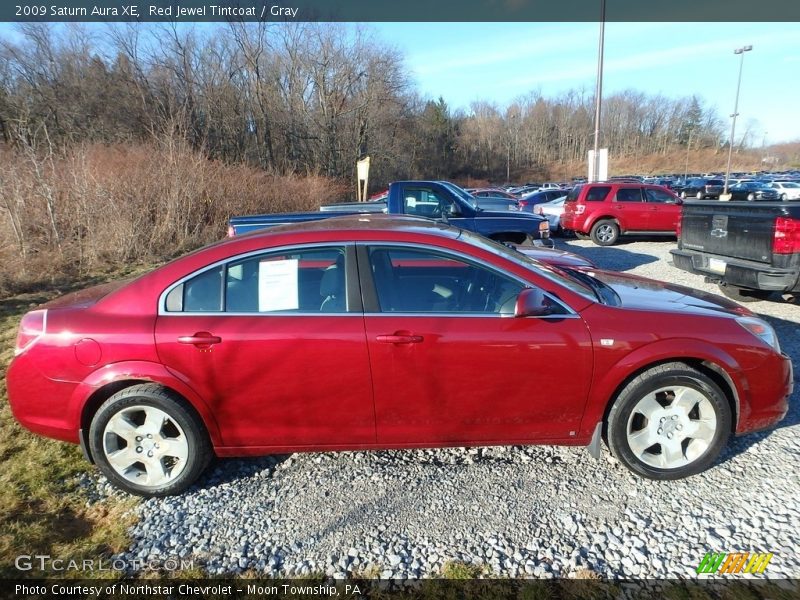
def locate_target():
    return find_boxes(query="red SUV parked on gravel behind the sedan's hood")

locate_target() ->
[561,182,681,246]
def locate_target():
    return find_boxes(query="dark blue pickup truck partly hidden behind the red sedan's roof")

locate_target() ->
[228,181,553,247]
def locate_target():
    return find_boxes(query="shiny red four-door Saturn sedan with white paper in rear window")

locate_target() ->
[7,215,792,496]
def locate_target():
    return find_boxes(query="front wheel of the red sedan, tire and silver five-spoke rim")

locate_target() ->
[607,362,733,480]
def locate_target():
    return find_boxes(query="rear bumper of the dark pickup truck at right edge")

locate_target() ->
[670,250,800,292]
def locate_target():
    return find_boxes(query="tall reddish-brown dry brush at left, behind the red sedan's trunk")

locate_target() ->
[0,142,348,294]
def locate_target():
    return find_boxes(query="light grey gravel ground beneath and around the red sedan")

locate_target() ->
[97,239,800,578]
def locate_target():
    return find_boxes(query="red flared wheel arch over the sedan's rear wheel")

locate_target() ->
[68,361,222,446]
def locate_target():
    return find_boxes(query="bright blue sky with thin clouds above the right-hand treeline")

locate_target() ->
[372,23,800,146]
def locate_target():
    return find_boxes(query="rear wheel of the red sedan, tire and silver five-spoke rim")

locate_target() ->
[89,384,212,497]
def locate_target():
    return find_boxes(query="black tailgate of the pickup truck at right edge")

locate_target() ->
[680,201,782,263]
